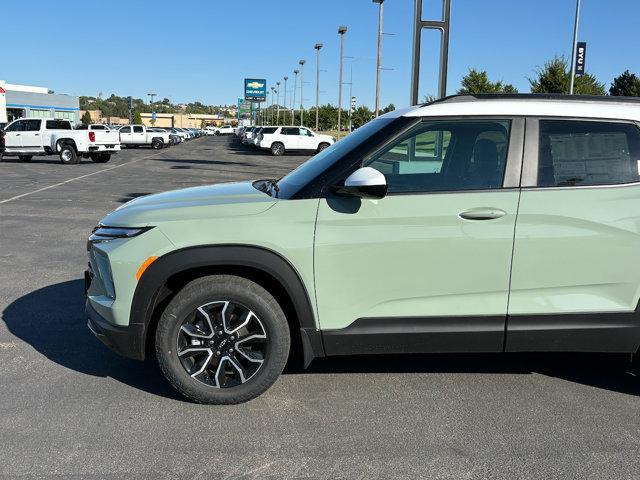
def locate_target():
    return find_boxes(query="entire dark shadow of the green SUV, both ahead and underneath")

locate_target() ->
[2,280,640,401]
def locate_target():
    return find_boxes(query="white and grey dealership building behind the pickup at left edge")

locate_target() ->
[0,80,80,123]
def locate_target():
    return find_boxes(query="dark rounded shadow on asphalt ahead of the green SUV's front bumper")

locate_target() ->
[2,280,184,400]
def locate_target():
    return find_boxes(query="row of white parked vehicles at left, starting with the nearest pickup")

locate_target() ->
[0,118,204,164]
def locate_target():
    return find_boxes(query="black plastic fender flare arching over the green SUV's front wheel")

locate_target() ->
[129,245,325,366]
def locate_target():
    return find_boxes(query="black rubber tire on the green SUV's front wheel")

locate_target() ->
[155,275,291,404]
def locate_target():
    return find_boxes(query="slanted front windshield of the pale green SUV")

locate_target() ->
[278,118,394,198]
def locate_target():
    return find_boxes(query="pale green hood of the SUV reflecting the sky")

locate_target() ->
[100,182,277,227]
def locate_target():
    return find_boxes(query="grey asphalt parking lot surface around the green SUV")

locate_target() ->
[0,137,640,479]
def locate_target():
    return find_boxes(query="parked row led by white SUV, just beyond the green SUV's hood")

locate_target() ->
[236,125,336,156]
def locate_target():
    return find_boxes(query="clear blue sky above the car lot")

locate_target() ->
[5,0,640,106]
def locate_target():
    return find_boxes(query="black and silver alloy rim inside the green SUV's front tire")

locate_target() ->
[176,300,267,388]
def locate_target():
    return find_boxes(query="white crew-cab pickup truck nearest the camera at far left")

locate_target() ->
[2,118,120,165]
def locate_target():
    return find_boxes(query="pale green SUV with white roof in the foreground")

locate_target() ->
[85,95,640,404]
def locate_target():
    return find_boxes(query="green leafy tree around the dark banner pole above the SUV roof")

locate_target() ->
[529,56,606,95]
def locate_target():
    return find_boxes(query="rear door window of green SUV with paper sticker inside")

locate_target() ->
[537,120,640,187]
